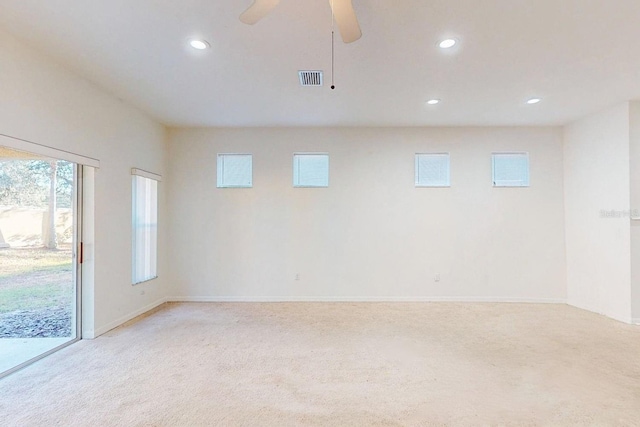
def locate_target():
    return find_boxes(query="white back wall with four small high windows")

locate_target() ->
[169,128,566,301]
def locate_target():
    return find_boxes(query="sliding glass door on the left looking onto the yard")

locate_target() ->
[0,146,82,375]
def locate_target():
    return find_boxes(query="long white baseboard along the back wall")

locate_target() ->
[167,296,566,304]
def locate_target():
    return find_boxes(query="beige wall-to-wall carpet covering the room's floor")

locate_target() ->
[0,303,640,426]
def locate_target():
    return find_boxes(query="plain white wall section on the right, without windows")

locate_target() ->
[564,103,631,322]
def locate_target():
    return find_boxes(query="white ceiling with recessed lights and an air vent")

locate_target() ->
[0,0,640,126]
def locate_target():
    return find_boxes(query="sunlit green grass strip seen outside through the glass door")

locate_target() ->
[0,248,74,314]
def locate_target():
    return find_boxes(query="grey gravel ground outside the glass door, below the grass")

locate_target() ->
[0,307,71,338]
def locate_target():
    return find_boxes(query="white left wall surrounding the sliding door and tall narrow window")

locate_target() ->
[0,32,168,335]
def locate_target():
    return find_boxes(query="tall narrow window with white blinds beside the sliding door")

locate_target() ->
[131,169,160,285]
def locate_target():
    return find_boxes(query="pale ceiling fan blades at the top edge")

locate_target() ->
[240,0,362,43]
